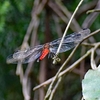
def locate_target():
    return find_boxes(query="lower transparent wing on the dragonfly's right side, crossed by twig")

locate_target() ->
[50,42,76,54]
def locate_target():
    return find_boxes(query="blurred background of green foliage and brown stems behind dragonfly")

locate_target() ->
[0,0,100,100]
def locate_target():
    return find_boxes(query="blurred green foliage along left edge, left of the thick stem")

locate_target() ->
[0,0,33,100]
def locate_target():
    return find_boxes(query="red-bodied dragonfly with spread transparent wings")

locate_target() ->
[7,29,90,64]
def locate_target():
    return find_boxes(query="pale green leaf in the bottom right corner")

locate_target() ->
[82,66,100,100]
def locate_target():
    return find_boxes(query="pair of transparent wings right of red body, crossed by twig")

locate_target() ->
[50,29,90,53]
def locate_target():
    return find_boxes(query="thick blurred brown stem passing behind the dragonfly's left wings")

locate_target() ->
[16,0,47,100]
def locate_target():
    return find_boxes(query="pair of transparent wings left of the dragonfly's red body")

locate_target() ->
[7,45,43,63]
